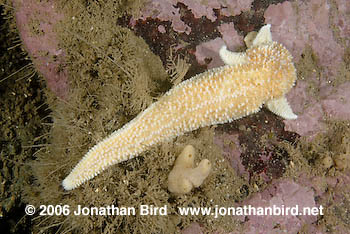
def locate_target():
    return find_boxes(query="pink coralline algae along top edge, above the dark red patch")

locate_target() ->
[131,0,253,34]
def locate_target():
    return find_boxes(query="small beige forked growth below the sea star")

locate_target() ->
[168,145,211,194]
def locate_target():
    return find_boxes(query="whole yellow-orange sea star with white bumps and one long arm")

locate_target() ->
[62,25,297,190]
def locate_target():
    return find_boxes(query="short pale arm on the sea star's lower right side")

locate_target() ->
[266,96,298,119]
